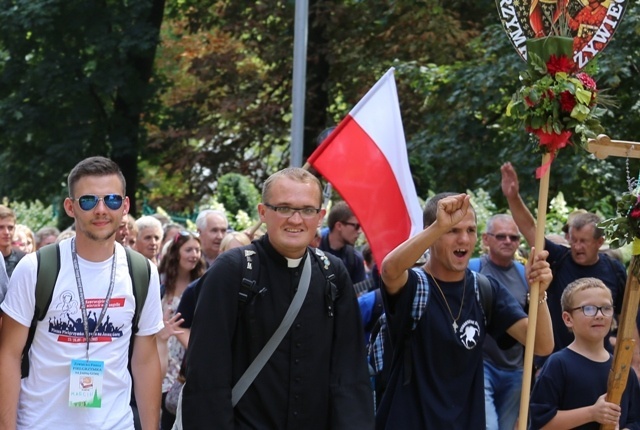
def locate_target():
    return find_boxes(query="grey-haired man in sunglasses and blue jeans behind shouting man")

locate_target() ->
[469,214,529,430]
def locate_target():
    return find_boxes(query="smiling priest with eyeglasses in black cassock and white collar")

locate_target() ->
[182,168,373,430]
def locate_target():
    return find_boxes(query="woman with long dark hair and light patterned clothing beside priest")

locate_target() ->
[157,231,205,430]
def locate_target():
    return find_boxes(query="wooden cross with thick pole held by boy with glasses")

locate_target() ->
[587,134,640,430]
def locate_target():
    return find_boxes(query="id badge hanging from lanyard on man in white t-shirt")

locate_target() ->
[69,360,104,408]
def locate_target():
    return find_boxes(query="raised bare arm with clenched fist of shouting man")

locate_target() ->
[380,194,470,295]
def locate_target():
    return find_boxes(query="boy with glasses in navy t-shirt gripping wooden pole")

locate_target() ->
[530,278,640,430]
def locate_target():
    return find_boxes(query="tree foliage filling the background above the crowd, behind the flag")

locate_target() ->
[0,0,640,223]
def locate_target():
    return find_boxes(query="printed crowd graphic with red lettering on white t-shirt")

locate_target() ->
[49,290,125,343]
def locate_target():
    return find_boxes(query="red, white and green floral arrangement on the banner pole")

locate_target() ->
[507,36,605,177]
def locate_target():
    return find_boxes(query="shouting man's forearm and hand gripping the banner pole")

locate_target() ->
[507,248,553,356]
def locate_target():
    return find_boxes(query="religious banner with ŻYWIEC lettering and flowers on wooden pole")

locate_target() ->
[496,0,637,430]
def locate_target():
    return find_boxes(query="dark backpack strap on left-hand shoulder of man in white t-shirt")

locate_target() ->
[20,243,60,378]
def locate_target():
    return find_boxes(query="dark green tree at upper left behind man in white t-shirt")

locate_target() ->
[0,0,164,215]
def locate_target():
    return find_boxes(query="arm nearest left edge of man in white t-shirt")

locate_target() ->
[0,315,29,429]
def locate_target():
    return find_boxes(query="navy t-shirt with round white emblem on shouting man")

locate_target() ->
[376,269,526,430]
